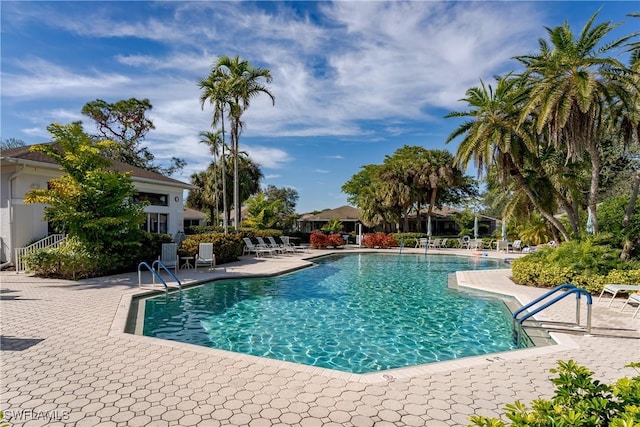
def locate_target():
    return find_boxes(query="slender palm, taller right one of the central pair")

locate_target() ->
[211,55,275,230]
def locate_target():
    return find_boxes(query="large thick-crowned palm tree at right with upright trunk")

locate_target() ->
[517,13,638,232]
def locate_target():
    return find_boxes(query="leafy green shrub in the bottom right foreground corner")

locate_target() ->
[471,360,640,427]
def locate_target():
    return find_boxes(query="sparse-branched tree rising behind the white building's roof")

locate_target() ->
[82,98,186,175]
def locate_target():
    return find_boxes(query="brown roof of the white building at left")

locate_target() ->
[0,142,193,188]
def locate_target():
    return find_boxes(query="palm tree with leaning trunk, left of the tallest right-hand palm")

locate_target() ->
[445,75,570,241]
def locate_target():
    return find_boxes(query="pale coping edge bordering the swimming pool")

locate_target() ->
[108,251,579,384]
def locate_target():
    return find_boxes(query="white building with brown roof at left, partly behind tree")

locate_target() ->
[0,146,193,264]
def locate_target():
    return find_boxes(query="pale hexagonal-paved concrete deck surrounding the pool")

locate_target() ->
[0,249,640,427]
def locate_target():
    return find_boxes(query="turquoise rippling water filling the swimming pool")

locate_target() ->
[143,254,528,373]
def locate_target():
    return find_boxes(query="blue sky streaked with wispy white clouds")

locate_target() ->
[0,1,640,213]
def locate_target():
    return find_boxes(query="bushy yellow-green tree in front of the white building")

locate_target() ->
[24,122,144,262]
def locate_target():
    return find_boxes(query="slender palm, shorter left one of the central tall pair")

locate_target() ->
[198,74,231,234]
